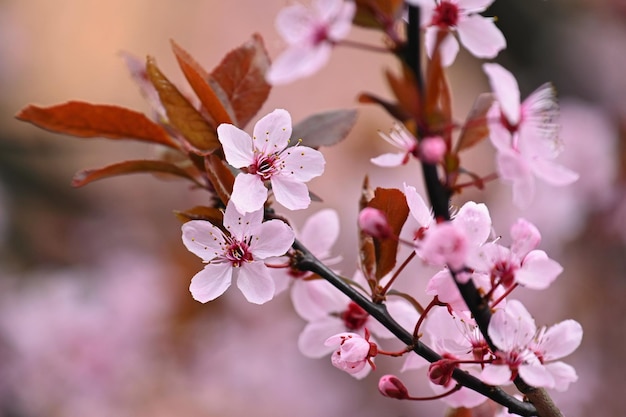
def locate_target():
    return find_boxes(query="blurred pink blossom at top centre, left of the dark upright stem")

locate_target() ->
[266,0,356,85]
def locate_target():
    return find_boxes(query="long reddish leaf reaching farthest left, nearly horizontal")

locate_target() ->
[16,101,179,148]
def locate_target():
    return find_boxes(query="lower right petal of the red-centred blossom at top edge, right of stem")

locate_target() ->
[457,14,506,58]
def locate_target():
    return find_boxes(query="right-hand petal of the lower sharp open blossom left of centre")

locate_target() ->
[250,220,295,259]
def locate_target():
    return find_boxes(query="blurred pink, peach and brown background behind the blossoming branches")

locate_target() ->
[0,0,626,417]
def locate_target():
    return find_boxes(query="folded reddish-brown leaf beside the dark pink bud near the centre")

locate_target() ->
[367,188,409,280]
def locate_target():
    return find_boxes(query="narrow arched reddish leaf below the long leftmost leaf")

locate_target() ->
[72,160,201,187]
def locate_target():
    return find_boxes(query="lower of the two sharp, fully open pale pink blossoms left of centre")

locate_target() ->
[182,201,295,304]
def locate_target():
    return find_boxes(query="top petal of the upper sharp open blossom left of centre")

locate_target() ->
[252,109,291,155]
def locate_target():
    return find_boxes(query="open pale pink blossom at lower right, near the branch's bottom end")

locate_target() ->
[481,300,582,390]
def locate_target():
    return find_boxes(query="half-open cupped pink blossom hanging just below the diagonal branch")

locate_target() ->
[324,332,376,379]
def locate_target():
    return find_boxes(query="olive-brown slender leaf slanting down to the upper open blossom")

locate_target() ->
[146,57,220,153]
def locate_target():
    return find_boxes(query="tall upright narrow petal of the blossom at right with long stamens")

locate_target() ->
[483,64,521,125]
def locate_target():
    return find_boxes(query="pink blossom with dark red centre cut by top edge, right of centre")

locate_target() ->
[407,0,506,66]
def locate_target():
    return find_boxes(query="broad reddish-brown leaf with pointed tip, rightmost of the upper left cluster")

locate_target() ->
[211,34,271,128]
